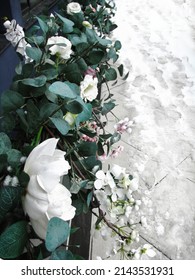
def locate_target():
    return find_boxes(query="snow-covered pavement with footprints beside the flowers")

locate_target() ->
[92,0,195,259]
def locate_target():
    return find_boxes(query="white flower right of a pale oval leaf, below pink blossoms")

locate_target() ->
[80,75,98,101]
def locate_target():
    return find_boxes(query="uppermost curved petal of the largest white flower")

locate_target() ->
[24,138,58,173]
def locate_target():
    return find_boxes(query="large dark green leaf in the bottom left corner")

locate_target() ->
[0,221,28,259]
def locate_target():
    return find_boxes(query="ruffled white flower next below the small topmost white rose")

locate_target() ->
[47,36,72,59]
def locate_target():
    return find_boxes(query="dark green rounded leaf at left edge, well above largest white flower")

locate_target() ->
[1,90,24,112]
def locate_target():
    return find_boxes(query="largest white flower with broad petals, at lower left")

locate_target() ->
[23,138,75,239]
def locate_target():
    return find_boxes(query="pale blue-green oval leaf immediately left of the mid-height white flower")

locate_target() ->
[49,82,77,99]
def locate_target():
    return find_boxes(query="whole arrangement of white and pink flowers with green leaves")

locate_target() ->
[0,0,155,259]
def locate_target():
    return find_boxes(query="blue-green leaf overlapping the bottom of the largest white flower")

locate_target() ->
[45,217,70,252]
